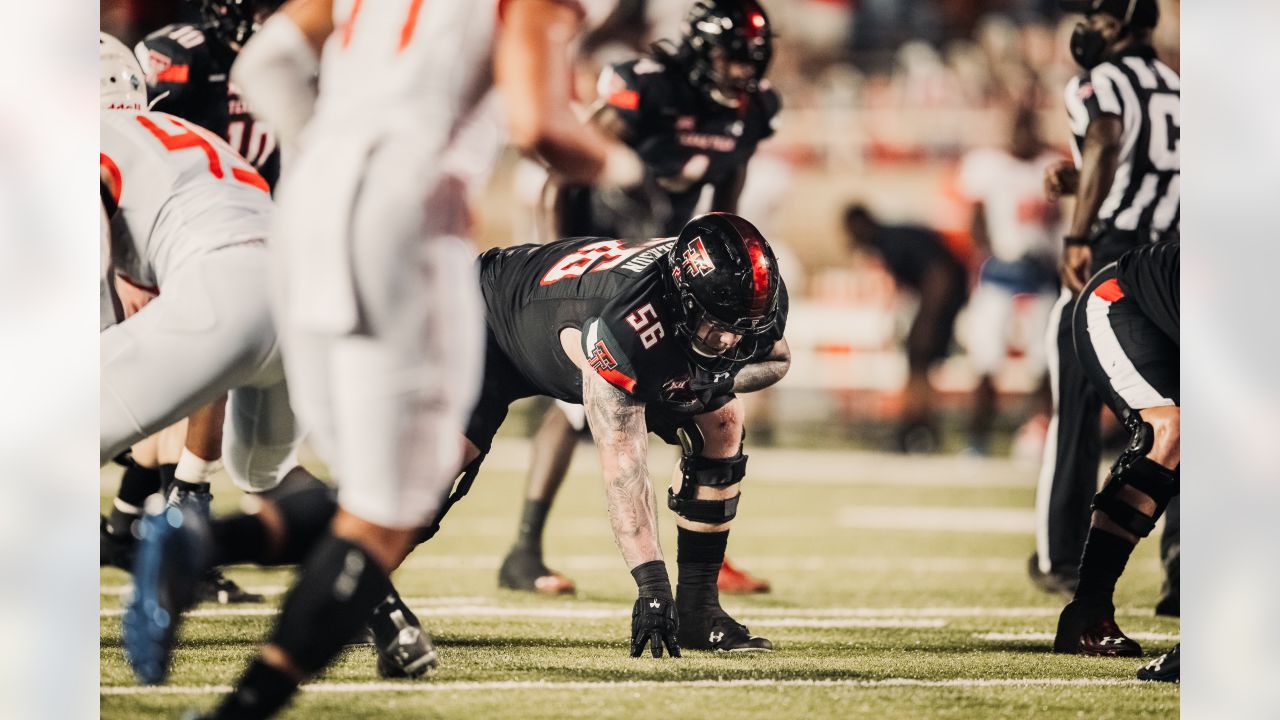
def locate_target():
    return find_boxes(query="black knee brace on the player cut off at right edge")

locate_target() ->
[1093,420,1179,538]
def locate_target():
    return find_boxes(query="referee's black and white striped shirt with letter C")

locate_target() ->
[1065,46,1181,240]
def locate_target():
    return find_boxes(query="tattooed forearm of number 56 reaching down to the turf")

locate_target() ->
[582,372,662,568]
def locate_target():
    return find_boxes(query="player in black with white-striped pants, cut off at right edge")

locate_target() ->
[1053,240,1181,682]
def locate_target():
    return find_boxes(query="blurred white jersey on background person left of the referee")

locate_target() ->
[959,147,1060,263]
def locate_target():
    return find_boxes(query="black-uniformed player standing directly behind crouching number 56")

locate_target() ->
[498,0,781,594]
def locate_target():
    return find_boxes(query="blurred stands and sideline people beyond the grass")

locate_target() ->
[101,0,1179,453]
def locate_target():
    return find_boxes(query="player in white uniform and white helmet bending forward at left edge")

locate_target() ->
[99,33,434,683]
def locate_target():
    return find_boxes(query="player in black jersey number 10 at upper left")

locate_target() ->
[134,0,283,188]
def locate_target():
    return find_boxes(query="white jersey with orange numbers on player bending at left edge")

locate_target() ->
[99,110,271,287]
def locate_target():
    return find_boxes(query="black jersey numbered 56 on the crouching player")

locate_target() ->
[480,237,787,407]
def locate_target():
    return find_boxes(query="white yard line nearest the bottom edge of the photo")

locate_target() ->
[101,678,1142,696]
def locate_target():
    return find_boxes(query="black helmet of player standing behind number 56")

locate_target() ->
[676,0,773,106]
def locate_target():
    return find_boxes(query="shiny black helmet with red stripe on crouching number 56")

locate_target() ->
[664,207,782,369]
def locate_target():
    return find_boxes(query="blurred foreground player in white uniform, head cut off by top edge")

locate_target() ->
[124,0,660,717]
